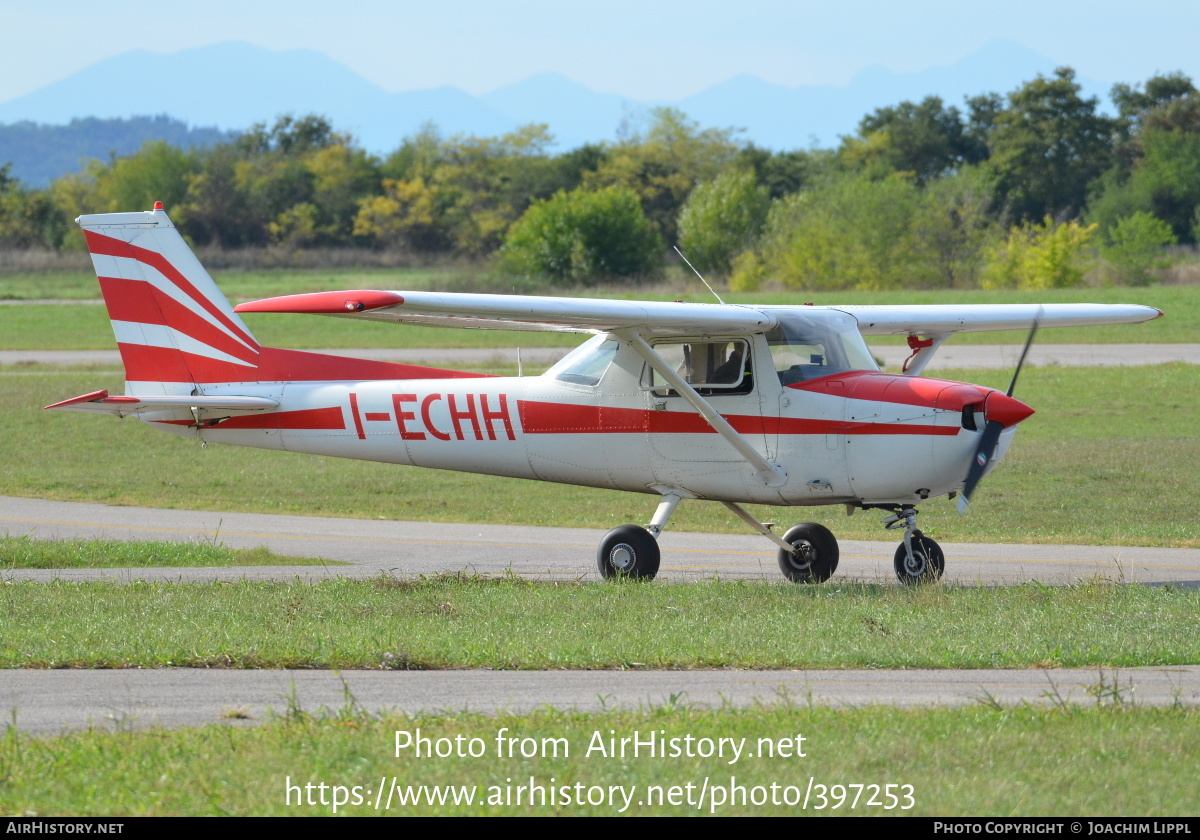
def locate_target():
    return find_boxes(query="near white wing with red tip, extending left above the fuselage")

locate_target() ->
[234,289,776,335]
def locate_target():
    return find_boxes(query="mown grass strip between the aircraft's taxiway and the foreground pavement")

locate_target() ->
[0,576,1200,670]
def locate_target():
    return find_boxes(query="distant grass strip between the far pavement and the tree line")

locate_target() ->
[0,282,1185,350]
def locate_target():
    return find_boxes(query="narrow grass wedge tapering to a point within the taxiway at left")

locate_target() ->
[0,536,348,570]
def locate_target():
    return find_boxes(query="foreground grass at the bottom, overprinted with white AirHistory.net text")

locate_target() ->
[0,698,1198,816]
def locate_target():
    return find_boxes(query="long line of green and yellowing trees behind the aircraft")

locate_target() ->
[0,67,1200,289]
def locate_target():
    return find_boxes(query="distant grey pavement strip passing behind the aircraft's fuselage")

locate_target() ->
[7,344,1200,371]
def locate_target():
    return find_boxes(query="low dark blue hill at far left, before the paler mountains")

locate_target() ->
[0,115,232,188]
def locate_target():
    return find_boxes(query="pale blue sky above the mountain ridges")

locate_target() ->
[0,0,1200,102]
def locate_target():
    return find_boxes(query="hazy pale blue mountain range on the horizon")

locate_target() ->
[0,41,1118,180]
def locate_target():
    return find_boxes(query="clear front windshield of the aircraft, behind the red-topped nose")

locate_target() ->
[767,310,880,385]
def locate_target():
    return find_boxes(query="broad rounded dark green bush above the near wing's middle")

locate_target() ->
[500,187,662,284]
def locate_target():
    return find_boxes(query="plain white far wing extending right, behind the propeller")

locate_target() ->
[825,304,1163,336]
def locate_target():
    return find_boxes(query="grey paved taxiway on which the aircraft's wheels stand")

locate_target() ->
[0,497,1200,586]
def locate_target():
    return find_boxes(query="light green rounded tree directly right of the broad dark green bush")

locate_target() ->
[679,172,770,275]
